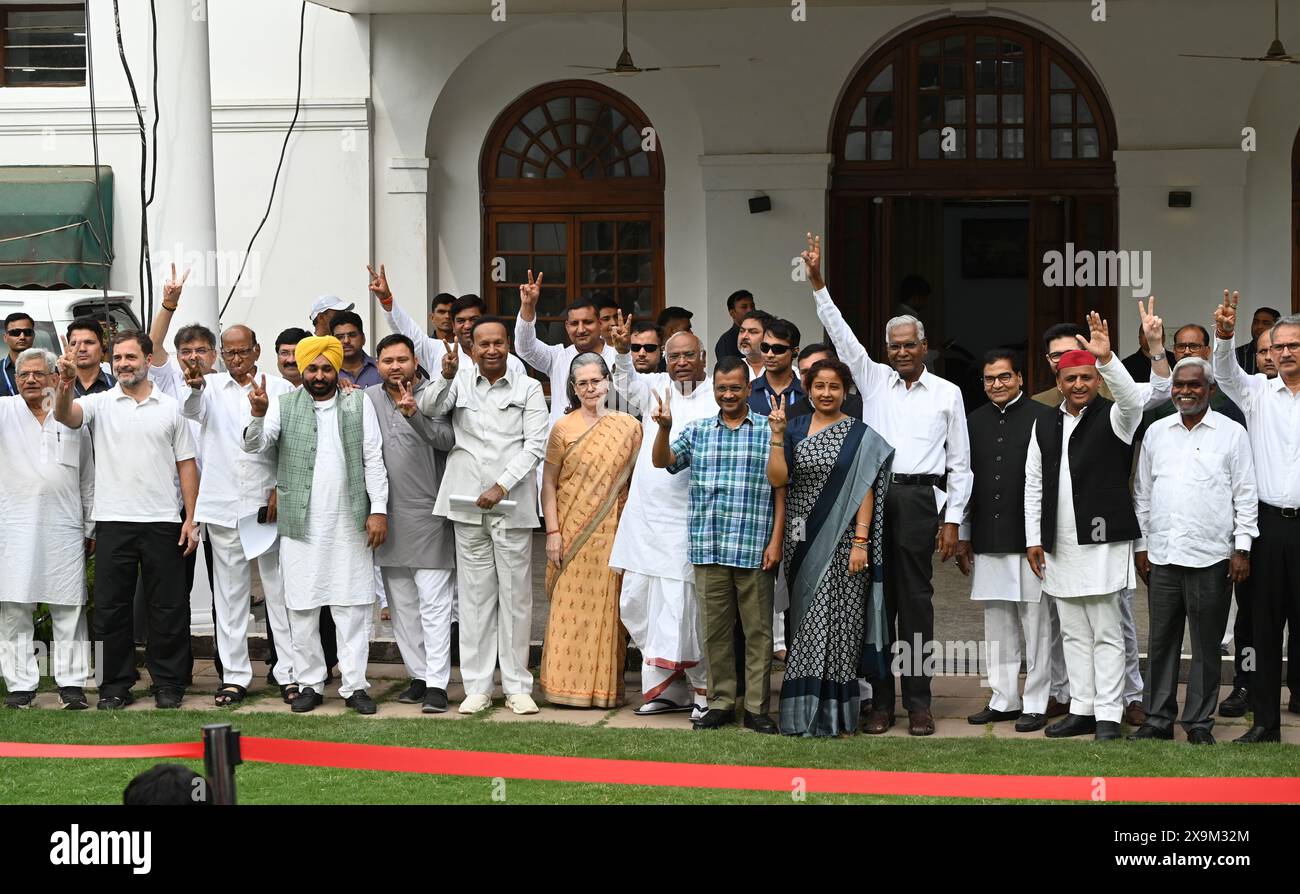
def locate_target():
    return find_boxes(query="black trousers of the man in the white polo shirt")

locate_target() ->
[95,521,194,696]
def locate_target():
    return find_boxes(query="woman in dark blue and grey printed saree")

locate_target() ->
[767,360,893,735]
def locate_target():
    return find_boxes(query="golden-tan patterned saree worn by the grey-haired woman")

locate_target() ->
[540,413,641,708]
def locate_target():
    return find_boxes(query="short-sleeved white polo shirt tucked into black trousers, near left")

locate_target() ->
[77,382,195,521]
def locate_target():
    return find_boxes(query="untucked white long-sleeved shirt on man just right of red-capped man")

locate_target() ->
[1134,409,1260,568]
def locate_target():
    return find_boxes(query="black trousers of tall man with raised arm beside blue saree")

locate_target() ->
[867,483,939,712]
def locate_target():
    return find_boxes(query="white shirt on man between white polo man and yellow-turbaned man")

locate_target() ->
[181,373,294,528]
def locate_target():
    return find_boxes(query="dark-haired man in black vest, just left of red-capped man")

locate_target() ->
[957,348,1054,733]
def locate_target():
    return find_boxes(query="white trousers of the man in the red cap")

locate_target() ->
[1056,590,1125,722]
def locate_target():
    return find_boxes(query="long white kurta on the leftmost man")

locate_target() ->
[0,395,95,606]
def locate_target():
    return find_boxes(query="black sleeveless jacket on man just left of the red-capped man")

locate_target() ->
[966,392,1056,554]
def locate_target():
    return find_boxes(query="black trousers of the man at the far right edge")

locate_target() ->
[1251,503,1300,729]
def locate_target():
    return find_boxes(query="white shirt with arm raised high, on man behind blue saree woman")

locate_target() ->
[814,288,974,525]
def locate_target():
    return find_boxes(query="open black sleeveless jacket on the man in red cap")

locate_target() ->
[1037,395,1141,552]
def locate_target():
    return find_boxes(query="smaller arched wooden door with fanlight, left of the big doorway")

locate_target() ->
[480,81,664,343]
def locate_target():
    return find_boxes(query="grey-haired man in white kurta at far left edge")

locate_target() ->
[0,348,95,709]
